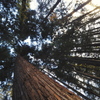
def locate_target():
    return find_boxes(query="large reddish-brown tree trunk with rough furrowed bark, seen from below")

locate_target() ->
[13,56,82,100]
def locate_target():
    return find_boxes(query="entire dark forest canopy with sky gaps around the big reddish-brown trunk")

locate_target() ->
[0,0,100,100]
